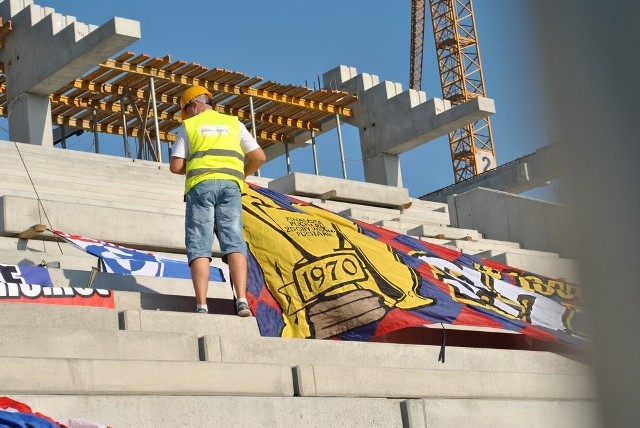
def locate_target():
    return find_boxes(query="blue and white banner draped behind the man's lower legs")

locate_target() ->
[51,230,228,282]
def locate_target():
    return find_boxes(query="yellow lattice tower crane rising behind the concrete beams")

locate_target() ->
[409,0,496,183]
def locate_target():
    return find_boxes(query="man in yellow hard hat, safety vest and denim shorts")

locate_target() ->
[169,86,266,317]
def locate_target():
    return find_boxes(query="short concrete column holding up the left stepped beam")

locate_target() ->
[8,92,53,147]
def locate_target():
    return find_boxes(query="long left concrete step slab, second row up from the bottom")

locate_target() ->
[0,357,293,396]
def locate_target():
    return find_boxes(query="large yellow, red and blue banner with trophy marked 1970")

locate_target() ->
[243,185,585,346]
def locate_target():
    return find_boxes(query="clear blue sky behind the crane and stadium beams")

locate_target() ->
[10,0,549,197]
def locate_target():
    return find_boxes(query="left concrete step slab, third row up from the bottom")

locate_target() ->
[0,324,199,361]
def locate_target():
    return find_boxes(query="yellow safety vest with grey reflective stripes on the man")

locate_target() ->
[184,110,245,195]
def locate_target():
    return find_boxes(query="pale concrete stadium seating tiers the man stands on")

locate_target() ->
[0,142,597,428]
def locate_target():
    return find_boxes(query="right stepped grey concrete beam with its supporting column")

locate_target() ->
[322,65,495,186]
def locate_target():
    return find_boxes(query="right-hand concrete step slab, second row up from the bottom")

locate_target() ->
[294,365,595,400]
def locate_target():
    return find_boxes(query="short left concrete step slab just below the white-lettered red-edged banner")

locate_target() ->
[0,302,119,330]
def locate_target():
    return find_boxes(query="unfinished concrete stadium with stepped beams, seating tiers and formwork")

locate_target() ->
[0,0,624,428]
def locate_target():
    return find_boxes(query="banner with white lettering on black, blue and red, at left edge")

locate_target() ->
[0,264,115,308]
